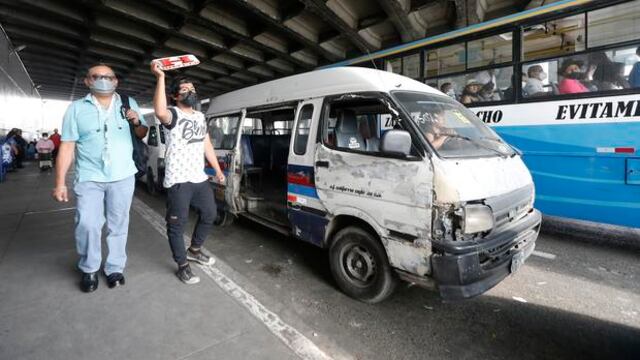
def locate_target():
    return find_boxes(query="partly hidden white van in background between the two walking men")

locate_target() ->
[140,112,166,194]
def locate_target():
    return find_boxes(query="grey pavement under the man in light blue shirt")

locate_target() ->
[0,164,297,360]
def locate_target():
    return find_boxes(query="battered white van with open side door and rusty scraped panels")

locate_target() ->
[207,67,541,303]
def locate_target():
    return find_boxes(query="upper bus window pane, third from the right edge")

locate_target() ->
[467,32,513,68]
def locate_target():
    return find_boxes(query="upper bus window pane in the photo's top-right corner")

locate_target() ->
[587,0,640,47]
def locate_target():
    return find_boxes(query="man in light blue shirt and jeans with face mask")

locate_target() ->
[53,64,147,292]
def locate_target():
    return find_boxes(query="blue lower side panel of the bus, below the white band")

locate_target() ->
[495,122,640,227]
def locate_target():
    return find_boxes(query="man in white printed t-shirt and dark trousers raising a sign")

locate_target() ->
[151,62,225,284]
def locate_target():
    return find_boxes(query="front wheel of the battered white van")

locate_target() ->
[329,226,397,304]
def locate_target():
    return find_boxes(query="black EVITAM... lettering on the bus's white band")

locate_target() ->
[556,100,640,120]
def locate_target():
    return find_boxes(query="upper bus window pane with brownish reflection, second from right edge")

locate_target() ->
[522,14,585,61]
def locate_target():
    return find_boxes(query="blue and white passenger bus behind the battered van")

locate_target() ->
[324,0,640,228]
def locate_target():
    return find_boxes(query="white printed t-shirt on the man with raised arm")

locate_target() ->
[163,107,208,188]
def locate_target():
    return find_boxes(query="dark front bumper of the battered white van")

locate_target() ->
[431,210,542,300]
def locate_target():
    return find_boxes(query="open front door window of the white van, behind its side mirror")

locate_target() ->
[322,97,390,153]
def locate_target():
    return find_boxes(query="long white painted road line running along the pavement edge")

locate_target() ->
[132,197,331,360]
